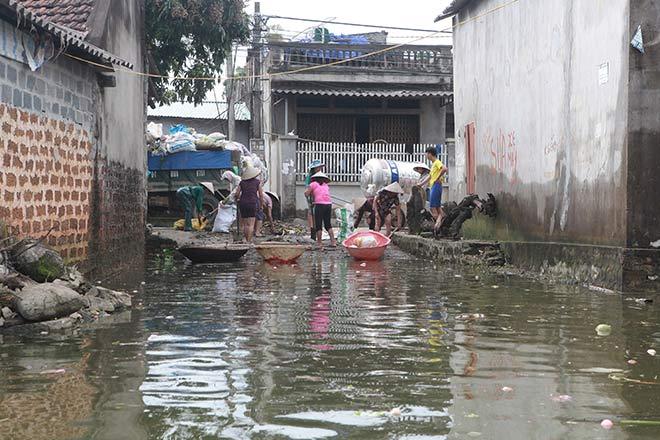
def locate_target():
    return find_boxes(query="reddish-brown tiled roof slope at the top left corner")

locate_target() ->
[12,0,94,34]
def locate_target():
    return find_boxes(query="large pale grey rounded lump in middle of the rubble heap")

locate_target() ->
[15,283,85,322]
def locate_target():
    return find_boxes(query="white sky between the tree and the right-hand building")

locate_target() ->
[211,0,451,96]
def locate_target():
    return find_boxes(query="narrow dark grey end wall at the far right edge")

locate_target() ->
[627,0,660,247]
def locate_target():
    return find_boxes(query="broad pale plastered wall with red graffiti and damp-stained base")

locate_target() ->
[450,0,630,245]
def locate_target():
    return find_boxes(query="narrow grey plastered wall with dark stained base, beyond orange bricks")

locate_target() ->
[90,0,147,265]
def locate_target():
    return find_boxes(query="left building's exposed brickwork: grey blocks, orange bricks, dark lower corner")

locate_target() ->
[0,52,146,274]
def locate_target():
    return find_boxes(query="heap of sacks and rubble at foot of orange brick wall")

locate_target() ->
[0,237,132,333]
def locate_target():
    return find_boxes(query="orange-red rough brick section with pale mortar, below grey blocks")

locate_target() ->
[0,103,93,260]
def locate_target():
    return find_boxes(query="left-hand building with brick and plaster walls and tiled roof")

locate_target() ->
[0,0,146,270]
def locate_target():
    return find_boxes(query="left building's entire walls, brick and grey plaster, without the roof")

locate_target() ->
[0,0,146,267]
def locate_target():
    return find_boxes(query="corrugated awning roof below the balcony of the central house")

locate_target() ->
[272,86,453,98]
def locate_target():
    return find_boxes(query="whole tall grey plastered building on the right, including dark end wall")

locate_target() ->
[439,0,660,286]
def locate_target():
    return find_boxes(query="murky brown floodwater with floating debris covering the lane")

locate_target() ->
[0,251,660,440]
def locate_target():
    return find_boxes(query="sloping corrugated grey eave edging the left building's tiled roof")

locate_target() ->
[9,0,133,69]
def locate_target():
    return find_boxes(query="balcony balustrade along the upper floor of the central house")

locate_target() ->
[269,42,452,76]
